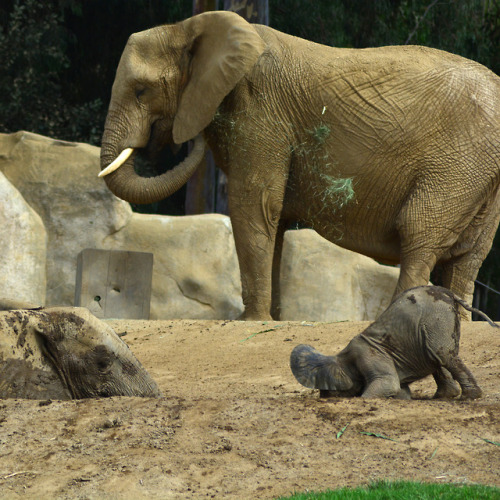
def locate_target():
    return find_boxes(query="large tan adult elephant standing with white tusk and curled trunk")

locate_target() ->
[101,12,500,319]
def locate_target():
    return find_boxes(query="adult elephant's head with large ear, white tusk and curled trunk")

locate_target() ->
[100,12,264,203]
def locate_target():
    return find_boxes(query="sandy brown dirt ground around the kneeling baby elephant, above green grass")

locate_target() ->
[0,320,500,499]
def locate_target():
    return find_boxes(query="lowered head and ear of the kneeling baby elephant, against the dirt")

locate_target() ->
[290,344,353,391]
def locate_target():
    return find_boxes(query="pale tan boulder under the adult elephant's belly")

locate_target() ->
[281,229,399,321]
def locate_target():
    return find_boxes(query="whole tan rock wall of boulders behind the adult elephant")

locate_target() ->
[0,132,398,321]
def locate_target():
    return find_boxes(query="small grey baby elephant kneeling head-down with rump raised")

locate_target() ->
[290,286,497,399]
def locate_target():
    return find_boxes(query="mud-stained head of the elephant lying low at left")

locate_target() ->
[31,308,160,399]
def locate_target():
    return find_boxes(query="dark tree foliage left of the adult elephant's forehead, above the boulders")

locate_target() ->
[0,0,191,145]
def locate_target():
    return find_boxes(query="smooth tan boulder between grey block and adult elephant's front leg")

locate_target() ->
[104,214,243,319]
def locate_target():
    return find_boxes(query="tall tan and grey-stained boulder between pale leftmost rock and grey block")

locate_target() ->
[0,132,132,306]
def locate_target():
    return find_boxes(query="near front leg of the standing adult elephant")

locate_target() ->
[229,183,285,320]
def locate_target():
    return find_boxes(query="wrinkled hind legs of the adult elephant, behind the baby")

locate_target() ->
[395,183,500,300]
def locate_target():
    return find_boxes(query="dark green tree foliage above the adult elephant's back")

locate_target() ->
[269,0,500,74]
